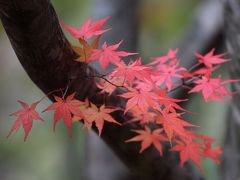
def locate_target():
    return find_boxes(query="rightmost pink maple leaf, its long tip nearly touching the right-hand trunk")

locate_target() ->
[188,76,233,102]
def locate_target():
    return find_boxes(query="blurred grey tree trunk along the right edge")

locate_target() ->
[222,0,240,180]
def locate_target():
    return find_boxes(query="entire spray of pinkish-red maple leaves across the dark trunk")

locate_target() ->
[9,17,238,170]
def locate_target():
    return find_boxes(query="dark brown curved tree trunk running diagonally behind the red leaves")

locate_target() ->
[0,0,201,180]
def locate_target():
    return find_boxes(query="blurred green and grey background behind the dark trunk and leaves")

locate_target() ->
[0,0,229,180]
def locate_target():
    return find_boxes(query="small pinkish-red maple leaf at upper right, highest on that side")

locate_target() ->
[195,49,229,68]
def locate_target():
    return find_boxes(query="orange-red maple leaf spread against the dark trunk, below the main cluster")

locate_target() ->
[126,126,167,155]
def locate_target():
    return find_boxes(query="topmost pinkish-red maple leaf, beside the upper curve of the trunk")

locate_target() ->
[62,16,110,39]
